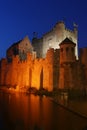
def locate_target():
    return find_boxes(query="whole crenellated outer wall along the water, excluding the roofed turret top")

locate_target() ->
[0,46,87,91]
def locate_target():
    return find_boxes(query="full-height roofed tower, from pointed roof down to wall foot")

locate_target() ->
[59,38,76,89]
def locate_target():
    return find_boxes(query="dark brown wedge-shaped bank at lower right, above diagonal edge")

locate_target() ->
[50,96,87,119]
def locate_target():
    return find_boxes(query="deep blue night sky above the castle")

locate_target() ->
[0,0,87,58]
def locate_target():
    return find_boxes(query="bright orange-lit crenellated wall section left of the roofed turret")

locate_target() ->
[0,48,58,91]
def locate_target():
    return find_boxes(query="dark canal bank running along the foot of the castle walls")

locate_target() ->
[0,87,87,119]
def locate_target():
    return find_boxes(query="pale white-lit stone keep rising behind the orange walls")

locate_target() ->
[32,21,78,59]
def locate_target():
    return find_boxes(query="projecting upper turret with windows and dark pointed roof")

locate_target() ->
[59,38,76,64]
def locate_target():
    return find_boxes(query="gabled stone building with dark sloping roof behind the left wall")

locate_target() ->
[6,36,33,62]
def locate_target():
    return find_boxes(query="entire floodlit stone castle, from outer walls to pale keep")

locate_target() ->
[0,22,87,91]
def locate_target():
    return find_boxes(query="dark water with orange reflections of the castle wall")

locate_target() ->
[0,92,87,130]
